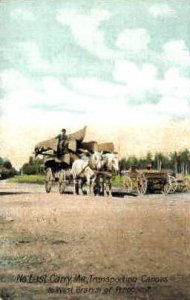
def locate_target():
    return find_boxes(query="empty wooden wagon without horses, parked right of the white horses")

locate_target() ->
[123,168,178,194]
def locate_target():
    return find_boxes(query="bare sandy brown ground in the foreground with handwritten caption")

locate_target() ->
[0,181,190,300]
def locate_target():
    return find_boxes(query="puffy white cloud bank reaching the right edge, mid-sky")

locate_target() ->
[69,60,190,112]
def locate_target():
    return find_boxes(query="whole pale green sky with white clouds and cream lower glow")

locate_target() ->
[0,0,190,167]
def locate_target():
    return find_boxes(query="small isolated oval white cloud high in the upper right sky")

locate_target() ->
[116,28,150,52]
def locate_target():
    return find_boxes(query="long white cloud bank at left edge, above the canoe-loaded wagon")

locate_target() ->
[1,69,124,126]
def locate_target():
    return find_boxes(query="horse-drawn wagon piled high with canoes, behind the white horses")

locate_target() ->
[35,126,115,195]
